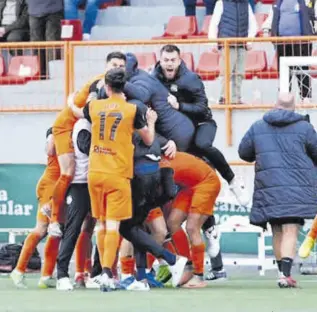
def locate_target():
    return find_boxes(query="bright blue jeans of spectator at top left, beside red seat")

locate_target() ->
[64,0,113,34]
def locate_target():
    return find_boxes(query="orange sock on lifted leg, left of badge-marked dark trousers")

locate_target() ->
[51,174,73,222]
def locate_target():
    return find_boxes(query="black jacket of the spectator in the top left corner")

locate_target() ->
[0,0,29,33]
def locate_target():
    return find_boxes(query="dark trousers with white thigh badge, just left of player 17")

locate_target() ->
[57,184,91,279]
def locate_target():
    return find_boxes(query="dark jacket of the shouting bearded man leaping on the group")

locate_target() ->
[153,61,212,123]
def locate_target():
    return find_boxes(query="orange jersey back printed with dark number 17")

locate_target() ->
[89,96,136,178]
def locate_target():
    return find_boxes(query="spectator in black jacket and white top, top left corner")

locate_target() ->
[0,0,30,42]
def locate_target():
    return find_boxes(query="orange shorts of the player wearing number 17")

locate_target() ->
[88,172,132,221]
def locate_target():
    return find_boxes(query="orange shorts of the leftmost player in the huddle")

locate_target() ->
[36,177,56,223]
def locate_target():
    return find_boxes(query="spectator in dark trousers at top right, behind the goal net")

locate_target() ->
[262,0,317,103]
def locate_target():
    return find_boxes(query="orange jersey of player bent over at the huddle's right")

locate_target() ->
[160,152,214,187]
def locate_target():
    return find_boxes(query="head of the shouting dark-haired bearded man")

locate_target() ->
[160,44,181,80]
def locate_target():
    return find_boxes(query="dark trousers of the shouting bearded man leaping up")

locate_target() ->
[193,120,234,183]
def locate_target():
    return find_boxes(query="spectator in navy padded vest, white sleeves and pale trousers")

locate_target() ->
[208,0,258,104]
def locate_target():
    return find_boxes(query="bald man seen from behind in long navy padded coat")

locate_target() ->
[239,93,317,288]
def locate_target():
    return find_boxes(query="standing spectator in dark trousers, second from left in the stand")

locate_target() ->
[27,0,64,79]
